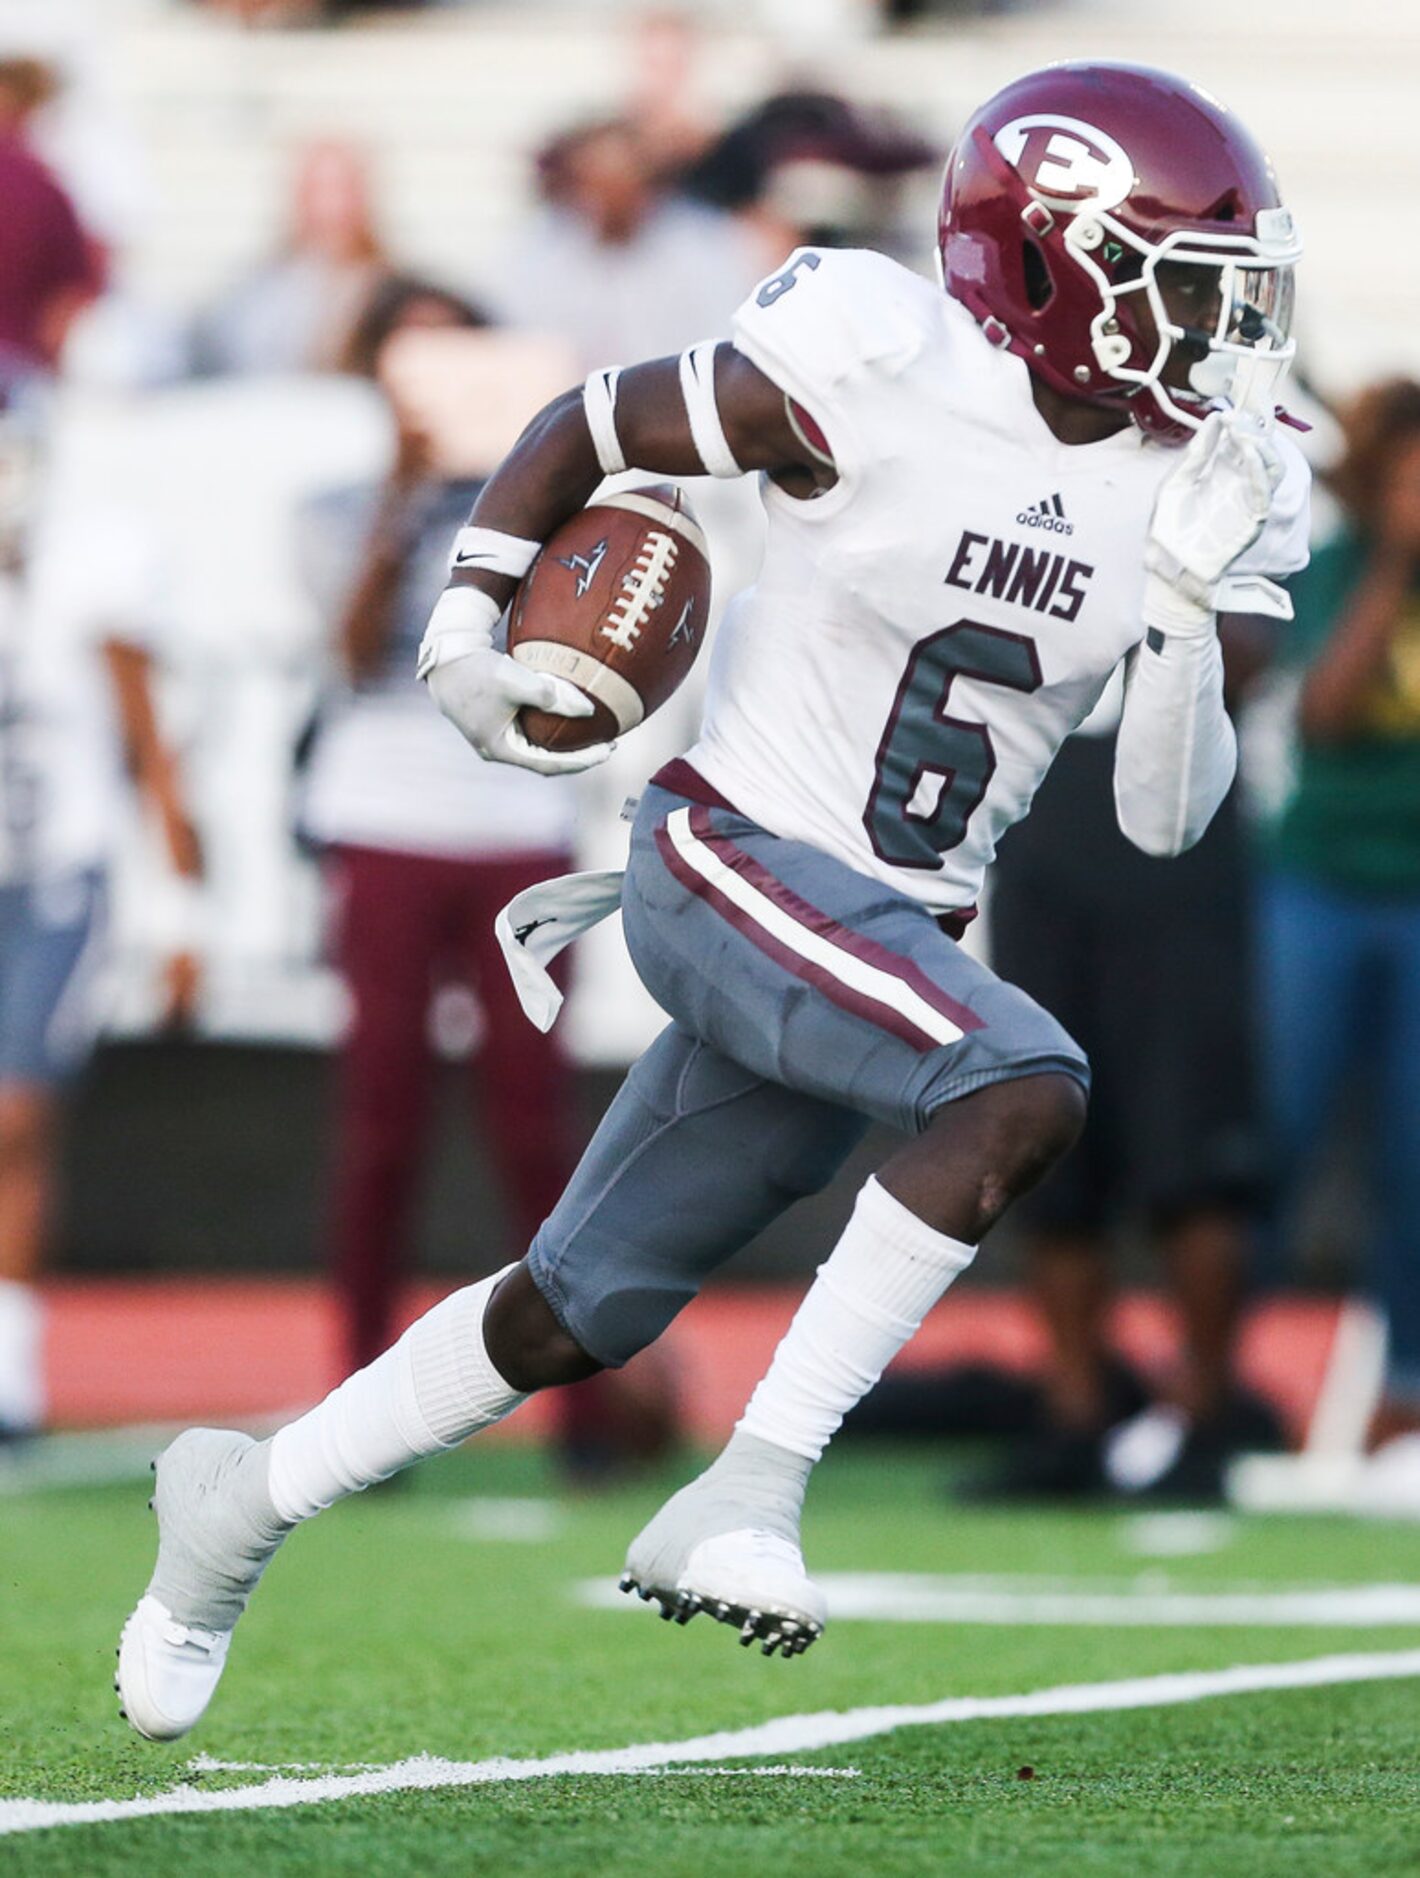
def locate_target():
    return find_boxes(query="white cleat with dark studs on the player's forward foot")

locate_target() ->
[620,1470,828,1656]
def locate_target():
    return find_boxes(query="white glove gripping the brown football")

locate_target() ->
[417,586,616,776]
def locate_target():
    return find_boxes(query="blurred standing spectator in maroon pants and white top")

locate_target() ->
[302,278,577,1367]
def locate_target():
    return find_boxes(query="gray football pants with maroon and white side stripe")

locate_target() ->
[528,787,1089,1365]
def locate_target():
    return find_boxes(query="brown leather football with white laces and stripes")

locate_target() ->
[507,483,710,749]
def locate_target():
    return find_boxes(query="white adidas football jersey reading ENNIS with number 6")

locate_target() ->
[687,248,1309,911]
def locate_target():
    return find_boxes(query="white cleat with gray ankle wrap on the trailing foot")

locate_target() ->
[113,1427,289,1741]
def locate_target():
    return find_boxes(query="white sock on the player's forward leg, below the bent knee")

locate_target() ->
[738,1179,977,1461]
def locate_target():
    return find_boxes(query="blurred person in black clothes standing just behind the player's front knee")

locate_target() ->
[982,625,1275,1499]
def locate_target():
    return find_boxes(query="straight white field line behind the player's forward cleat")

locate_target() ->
[575,1572,1420,1630]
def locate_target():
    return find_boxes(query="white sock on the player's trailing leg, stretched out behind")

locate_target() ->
[269,1266,528,1523]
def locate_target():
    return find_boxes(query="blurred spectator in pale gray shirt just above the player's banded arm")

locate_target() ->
[494,118,764,370]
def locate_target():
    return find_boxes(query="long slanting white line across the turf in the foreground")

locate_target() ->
[0,1649,1420,1833]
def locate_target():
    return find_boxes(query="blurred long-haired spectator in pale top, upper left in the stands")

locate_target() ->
[193,141,389,374]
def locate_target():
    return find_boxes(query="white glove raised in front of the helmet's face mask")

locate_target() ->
[1144,409,1283,635]
